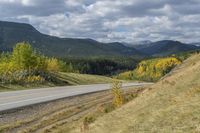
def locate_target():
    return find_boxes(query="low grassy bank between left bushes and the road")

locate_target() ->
[0,72,113,92]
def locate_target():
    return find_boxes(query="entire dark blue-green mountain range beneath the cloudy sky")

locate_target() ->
[0,21,200,58]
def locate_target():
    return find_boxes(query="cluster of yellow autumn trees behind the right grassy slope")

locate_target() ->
[117,57,181,81]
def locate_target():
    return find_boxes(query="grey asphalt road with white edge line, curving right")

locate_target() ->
[0,83,152,112]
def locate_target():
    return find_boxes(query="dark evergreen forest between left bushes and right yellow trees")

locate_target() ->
[63,57,140,76]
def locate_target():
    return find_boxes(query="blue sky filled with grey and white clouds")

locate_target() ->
[0,0,200,43]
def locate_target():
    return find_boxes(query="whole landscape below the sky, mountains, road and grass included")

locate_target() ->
[0,21,200,133]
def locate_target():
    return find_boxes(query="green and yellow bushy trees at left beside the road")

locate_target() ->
[0,43,63,84]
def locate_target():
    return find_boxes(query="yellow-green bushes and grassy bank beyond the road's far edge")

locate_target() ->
[0,42,112,91]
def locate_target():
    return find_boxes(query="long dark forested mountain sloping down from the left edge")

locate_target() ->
[0,21,141,57]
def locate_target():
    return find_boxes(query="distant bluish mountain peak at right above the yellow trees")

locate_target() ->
[134,40,199,56]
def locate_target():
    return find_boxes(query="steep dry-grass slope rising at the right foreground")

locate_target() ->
[83,54,200,133]
